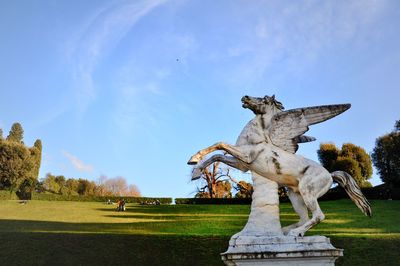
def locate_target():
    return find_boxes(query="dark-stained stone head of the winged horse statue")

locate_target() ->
[242,95,284,115]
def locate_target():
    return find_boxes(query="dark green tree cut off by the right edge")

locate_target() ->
[371,120,400,187]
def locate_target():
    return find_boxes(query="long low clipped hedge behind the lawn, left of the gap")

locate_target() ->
[32,193,172,204]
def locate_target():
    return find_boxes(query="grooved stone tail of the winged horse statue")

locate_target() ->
[331,171,372,217]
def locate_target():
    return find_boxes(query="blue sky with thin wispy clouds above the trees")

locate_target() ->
[0,0,400,197]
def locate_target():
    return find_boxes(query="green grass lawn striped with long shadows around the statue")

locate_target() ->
[0,200,400,265]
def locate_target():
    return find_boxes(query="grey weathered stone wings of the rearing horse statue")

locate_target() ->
[269,104,351,153]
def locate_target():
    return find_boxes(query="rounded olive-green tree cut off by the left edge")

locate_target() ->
[0,141,34,193]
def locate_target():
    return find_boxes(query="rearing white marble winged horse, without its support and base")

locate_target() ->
[188,96,372,236]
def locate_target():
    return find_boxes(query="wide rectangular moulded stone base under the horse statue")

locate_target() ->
[221,235,343,266]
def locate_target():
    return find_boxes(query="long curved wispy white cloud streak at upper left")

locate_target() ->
[66,0,166,112]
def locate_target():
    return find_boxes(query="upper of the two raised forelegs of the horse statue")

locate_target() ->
[188,142,262,164]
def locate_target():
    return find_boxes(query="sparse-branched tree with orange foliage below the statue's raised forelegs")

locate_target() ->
[195,162,232,198]
